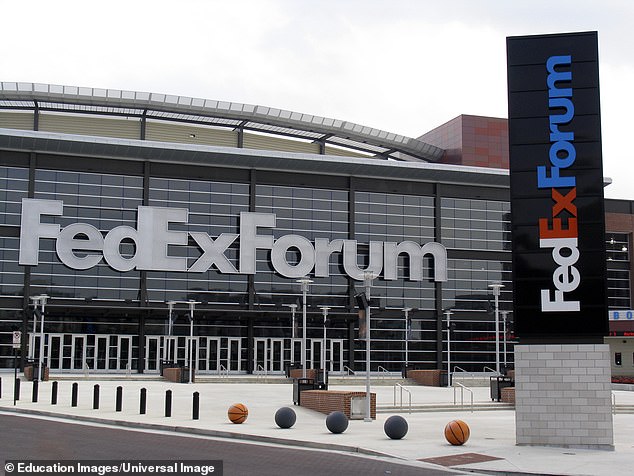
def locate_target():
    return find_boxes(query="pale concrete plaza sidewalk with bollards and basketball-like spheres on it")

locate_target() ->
[0,373,634,476]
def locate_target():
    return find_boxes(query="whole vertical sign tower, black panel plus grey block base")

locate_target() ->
[507,32,614,449]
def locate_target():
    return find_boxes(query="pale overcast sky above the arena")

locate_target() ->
[0,0,634,199]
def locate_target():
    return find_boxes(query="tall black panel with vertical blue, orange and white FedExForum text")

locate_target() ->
[506,32,608,343]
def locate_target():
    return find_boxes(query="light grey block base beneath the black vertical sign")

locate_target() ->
[515,344,614,450]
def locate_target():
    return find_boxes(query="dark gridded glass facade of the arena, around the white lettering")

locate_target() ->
[0,151,631,373]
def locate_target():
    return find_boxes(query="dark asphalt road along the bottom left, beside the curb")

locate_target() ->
[0,414,460,476]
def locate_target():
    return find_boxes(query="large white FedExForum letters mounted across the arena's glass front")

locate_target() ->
[19,198,446,281]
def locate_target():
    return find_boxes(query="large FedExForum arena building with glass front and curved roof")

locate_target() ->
[0,82,634,375]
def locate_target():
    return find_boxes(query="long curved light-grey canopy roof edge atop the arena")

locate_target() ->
[0,82,444,162]
